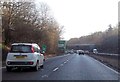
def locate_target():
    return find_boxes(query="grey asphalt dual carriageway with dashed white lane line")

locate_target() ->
[2,54,119,80]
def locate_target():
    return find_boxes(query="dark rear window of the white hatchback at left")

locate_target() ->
[10,45,32,53]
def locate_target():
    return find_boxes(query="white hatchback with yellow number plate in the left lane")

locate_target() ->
[6,43,44,71]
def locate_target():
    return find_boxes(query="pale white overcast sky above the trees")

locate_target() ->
[36,0,119,40]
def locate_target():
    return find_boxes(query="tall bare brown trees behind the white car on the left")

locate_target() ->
[2,2,62,53]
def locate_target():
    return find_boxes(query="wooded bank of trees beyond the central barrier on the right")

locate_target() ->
[68,25,120,53]
